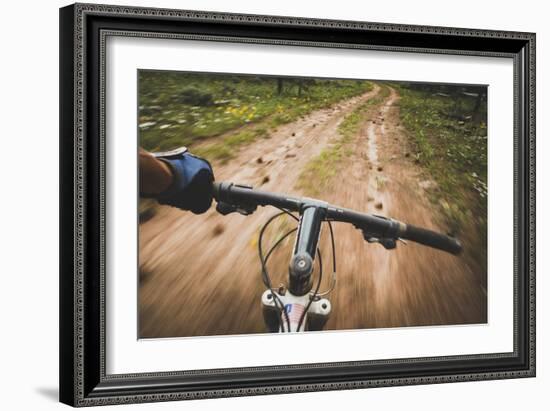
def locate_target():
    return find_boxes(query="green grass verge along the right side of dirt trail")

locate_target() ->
[398,86,487,248]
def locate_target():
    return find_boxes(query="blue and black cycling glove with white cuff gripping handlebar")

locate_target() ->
[155,148,214,214]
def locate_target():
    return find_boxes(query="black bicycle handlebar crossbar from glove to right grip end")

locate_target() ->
[213,182,462,254]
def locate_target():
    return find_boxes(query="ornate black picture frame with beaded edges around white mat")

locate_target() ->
[60,4,535,406]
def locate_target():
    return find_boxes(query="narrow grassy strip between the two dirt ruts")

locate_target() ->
[296,85,390,196]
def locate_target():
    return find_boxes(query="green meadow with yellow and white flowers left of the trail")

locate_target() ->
[139,71,378,160]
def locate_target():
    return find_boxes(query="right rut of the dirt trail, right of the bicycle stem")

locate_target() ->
[314,88,487,329]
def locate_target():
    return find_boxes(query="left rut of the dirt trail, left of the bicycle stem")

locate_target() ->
[139,86,379,337]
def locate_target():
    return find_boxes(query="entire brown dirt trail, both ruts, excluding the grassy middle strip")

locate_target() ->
[139,86,487,337]
